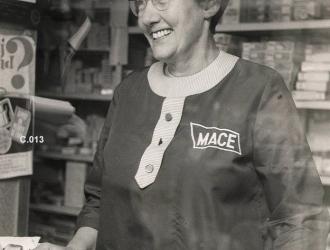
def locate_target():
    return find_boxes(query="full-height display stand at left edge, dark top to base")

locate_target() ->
[0,0,40,236]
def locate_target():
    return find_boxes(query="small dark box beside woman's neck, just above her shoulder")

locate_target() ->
[213,33,242,56]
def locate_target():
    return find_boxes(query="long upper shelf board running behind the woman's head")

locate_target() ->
[128,20,330,34]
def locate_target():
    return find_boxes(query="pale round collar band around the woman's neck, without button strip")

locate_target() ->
[148,51,238,97]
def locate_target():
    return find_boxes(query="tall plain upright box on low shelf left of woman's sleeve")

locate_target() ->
[64,161,87,208]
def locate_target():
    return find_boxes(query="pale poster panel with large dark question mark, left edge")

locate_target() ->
[0,34,36,94]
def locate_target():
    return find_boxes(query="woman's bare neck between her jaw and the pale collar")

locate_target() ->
[167,34,219,76]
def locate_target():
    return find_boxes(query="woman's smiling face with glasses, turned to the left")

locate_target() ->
[138,0,205,63]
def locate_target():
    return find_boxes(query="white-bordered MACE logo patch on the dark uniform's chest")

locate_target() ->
[190,122,242,155]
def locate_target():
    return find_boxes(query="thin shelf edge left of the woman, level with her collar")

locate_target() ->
[37,91,113,101]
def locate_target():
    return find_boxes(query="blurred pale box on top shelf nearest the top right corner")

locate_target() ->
[293,0,322,20]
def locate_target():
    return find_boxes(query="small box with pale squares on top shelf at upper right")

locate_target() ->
[268,0,292,22]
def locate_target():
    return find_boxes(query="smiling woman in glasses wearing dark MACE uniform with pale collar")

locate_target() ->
[37,0,328,250]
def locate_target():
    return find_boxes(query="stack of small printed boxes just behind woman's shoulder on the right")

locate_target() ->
[242,41,300,89]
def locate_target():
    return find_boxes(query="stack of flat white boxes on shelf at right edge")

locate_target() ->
[293,44,330,101]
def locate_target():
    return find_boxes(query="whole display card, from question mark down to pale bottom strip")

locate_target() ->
[0,31,36,180]
